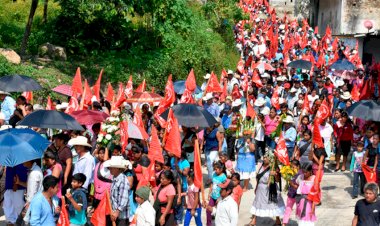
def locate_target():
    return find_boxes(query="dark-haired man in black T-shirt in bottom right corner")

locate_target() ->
[352,183,380,226]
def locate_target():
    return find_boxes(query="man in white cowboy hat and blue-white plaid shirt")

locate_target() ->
[104,156,131,226]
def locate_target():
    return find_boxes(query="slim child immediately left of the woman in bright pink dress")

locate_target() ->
[282,159,301,225]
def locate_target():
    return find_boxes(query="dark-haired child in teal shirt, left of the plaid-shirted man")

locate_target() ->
[66,173,87,225]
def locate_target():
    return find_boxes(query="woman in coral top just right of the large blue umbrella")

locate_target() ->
[43,149,63,198]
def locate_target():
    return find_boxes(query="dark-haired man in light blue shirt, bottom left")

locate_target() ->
[30,175,59,226]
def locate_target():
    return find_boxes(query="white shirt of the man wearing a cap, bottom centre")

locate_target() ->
[212,195,239,226]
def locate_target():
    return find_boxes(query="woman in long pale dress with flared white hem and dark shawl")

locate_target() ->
[249,150,285,225]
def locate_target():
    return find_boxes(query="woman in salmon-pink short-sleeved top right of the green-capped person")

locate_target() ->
[153,170,176,226]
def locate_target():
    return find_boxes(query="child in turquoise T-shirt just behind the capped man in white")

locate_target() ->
[203,161,227,226]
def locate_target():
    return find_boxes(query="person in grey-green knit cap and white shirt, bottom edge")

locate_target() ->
[135,186,156,226]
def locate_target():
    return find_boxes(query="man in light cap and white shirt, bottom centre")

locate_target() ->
[207,179,239,226]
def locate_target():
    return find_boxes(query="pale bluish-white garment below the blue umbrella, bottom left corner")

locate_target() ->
[3,189,25,224]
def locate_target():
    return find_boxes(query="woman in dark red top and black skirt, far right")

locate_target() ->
[334,112,354,172]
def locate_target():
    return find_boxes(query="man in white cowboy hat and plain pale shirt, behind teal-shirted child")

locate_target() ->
[69,136,95,189]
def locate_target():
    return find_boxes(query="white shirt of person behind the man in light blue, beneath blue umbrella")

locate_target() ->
[26,163,44,202]
